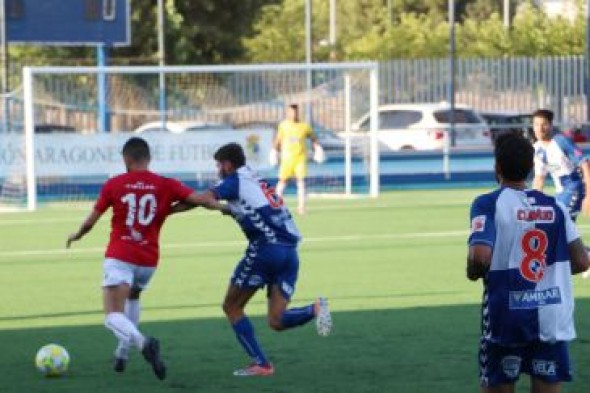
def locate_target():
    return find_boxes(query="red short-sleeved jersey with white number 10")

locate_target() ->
[94,170,193,266]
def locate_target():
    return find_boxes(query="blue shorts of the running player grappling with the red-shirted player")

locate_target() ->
[230,243,299,300]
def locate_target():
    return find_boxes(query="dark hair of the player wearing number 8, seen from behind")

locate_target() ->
[494,133,535,181]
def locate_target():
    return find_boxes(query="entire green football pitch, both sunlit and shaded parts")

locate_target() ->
[0,189,590,393]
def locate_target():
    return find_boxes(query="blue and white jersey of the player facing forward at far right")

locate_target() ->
[533,134,585,193]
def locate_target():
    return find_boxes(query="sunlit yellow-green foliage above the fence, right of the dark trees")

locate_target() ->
[244,0,586,61]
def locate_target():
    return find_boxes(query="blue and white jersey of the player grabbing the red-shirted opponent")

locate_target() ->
[212,166,301,245]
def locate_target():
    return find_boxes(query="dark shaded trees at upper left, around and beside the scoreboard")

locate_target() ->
[10,0,277,72]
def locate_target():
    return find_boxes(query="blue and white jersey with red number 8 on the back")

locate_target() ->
[469,188,579,345]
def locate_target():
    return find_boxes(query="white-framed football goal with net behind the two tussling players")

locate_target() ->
[15,63,378,208]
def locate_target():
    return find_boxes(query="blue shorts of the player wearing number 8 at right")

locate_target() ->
[479,339,572,388]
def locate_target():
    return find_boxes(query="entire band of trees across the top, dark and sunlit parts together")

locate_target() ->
[4,0,586,72]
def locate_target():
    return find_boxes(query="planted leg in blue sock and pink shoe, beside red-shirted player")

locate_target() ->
[223,284,274,377]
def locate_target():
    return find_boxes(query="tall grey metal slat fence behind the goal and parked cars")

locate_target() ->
[0,56,588,131]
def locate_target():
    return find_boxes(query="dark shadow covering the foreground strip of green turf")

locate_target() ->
[0,299,590,393]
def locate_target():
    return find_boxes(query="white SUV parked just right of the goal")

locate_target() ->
[350,103,490,150]
